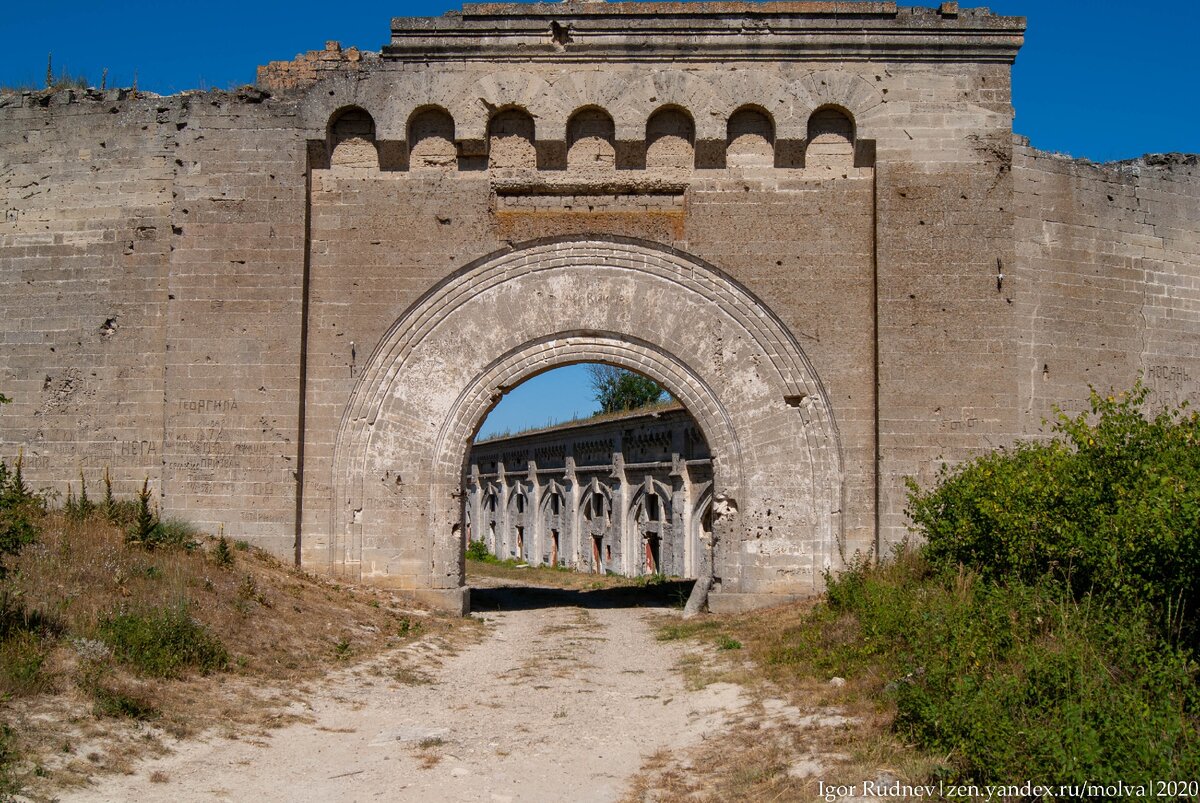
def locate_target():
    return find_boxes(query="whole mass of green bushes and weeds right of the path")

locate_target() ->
[767,385,1200,784]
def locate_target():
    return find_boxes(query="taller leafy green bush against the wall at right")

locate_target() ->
[908,385,1200,646]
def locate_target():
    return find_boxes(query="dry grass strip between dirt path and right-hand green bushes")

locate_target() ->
[625,604,931,803]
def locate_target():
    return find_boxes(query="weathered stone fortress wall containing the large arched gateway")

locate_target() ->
[0,2,1200,609]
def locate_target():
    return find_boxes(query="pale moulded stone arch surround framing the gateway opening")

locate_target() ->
[330,238,842,610]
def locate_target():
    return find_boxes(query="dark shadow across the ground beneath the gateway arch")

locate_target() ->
[470,580,696,612]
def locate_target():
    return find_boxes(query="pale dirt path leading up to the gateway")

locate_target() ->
[61,578,744,803]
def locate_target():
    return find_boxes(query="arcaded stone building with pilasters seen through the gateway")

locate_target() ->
[464,407,713,579]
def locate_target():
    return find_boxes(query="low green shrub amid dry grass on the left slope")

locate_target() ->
[98,605,229,677]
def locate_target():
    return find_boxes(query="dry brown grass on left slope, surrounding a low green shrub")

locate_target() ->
[0,515,478,799]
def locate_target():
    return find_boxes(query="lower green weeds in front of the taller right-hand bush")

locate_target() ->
[816,556,1200,784]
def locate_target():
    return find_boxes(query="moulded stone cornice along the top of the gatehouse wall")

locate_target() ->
[383,2,1025,64]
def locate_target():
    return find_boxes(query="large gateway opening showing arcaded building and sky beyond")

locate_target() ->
[462,364,713,582]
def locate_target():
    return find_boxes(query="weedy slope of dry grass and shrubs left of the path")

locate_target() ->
[0,463,456,798]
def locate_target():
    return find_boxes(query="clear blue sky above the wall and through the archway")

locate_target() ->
[0,0,1200,439]
